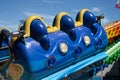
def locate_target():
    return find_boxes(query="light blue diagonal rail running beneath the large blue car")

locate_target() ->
[42,52,107,80]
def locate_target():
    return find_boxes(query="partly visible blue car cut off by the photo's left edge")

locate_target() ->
[0,29,11,79]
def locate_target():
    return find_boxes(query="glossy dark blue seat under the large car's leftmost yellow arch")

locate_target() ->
[30,20,50,50]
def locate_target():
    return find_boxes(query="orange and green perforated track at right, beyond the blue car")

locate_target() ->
[104,20,120,64]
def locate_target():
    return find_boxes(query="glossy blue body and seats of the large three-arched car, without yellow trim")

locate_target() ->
[13,12,108,80]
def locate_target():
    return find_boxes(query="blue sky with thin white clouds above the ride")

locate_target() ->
[0,0,120,31]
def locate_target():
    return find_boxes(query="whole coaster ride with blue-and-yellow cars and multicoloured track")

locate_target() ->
[0,9,120,80]
